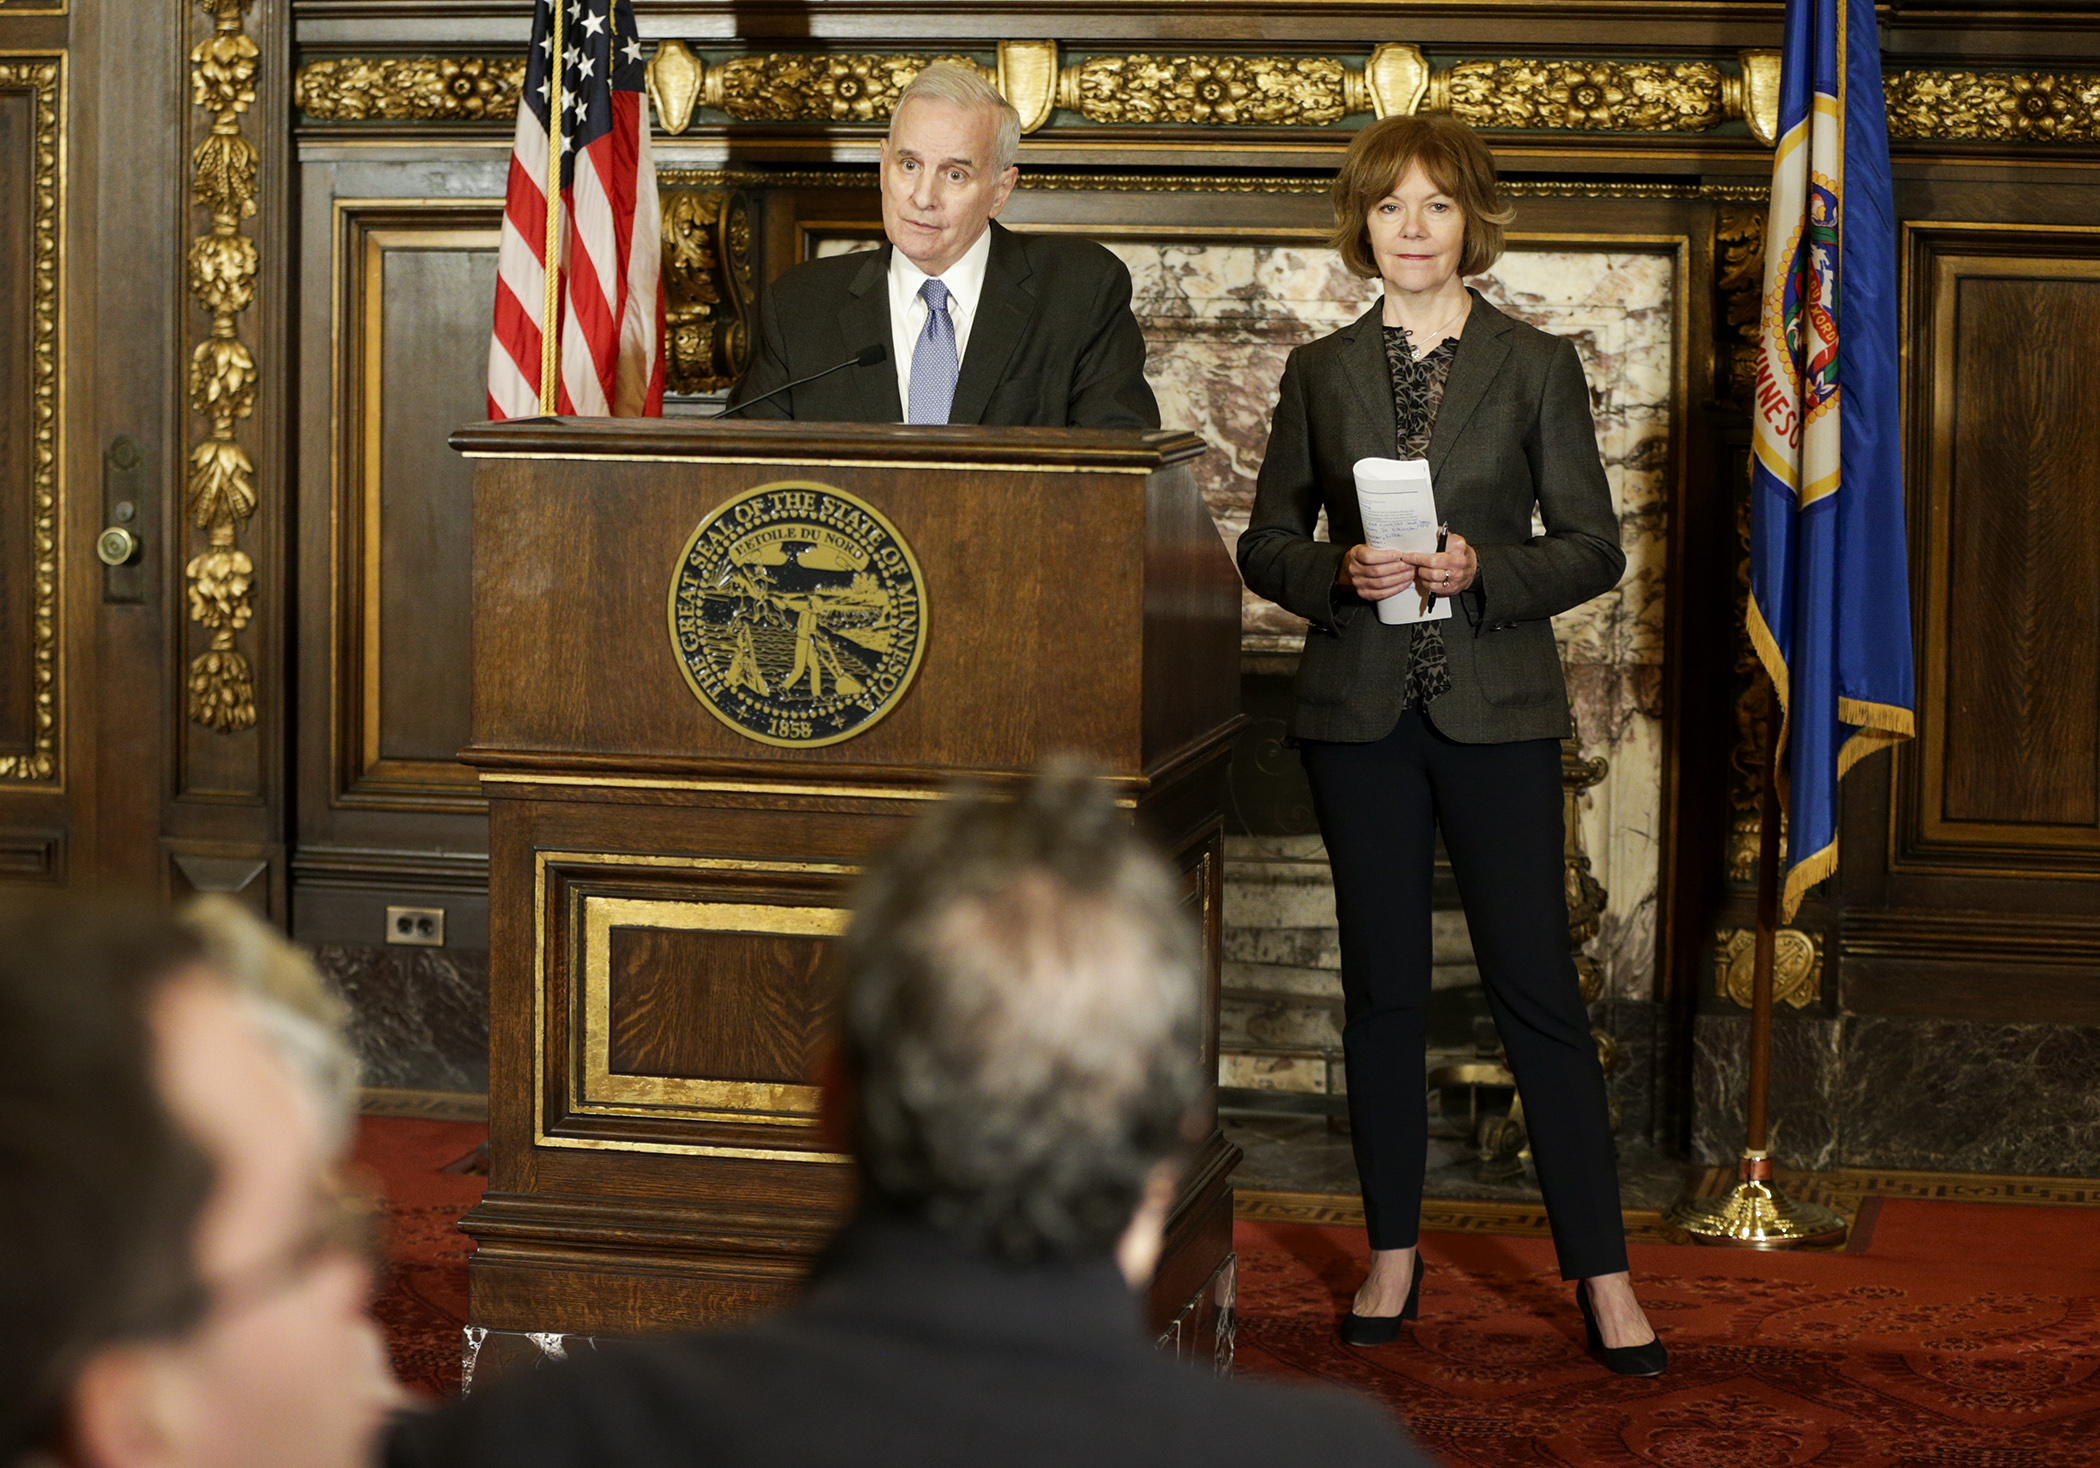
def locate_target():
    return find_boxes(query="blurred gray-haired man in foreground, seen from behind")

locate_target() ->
[391,773,1422,1468]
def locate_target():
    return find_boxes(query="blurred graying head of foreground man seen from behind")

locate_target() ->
[834,764,1203,1285]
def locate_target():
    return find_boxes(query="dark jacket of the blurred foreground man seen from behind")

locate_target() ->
[386,1218,1426,1468]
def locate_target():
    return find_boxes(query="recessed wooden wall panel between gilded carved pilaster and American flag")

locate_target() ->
[333,200,502,811]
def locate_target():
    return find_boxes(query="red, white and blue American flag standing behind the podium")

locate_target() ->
[489,0,664,418]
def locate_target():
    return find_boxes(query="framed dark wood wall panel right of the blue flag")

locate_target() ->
[1894,229,2100,876]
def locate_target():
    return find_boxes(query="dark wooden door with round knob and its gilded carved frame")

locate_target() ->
[0,0,284,911]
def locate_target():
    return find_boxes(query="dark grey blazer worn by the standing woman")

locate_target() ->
[1239,292,1625,743]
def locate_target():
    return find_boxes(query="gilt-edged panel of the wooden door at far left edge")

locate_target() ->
[0,57,63,788]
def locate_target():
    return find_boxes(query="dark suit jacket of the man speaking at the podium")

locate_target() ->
[729,221,1159,428]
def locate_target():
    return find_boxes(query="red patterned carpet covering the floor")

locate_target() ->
[359,1117,2100,1468]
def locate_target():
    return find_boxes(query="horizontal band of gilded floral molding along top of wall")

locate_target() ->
[294,40,2100,143]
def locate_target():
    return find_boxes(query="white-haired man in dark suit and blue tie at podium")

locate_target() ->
[727,63,1159,428]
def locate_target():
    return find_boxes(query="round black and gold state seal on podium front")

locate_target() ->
[670,479,926,748]
